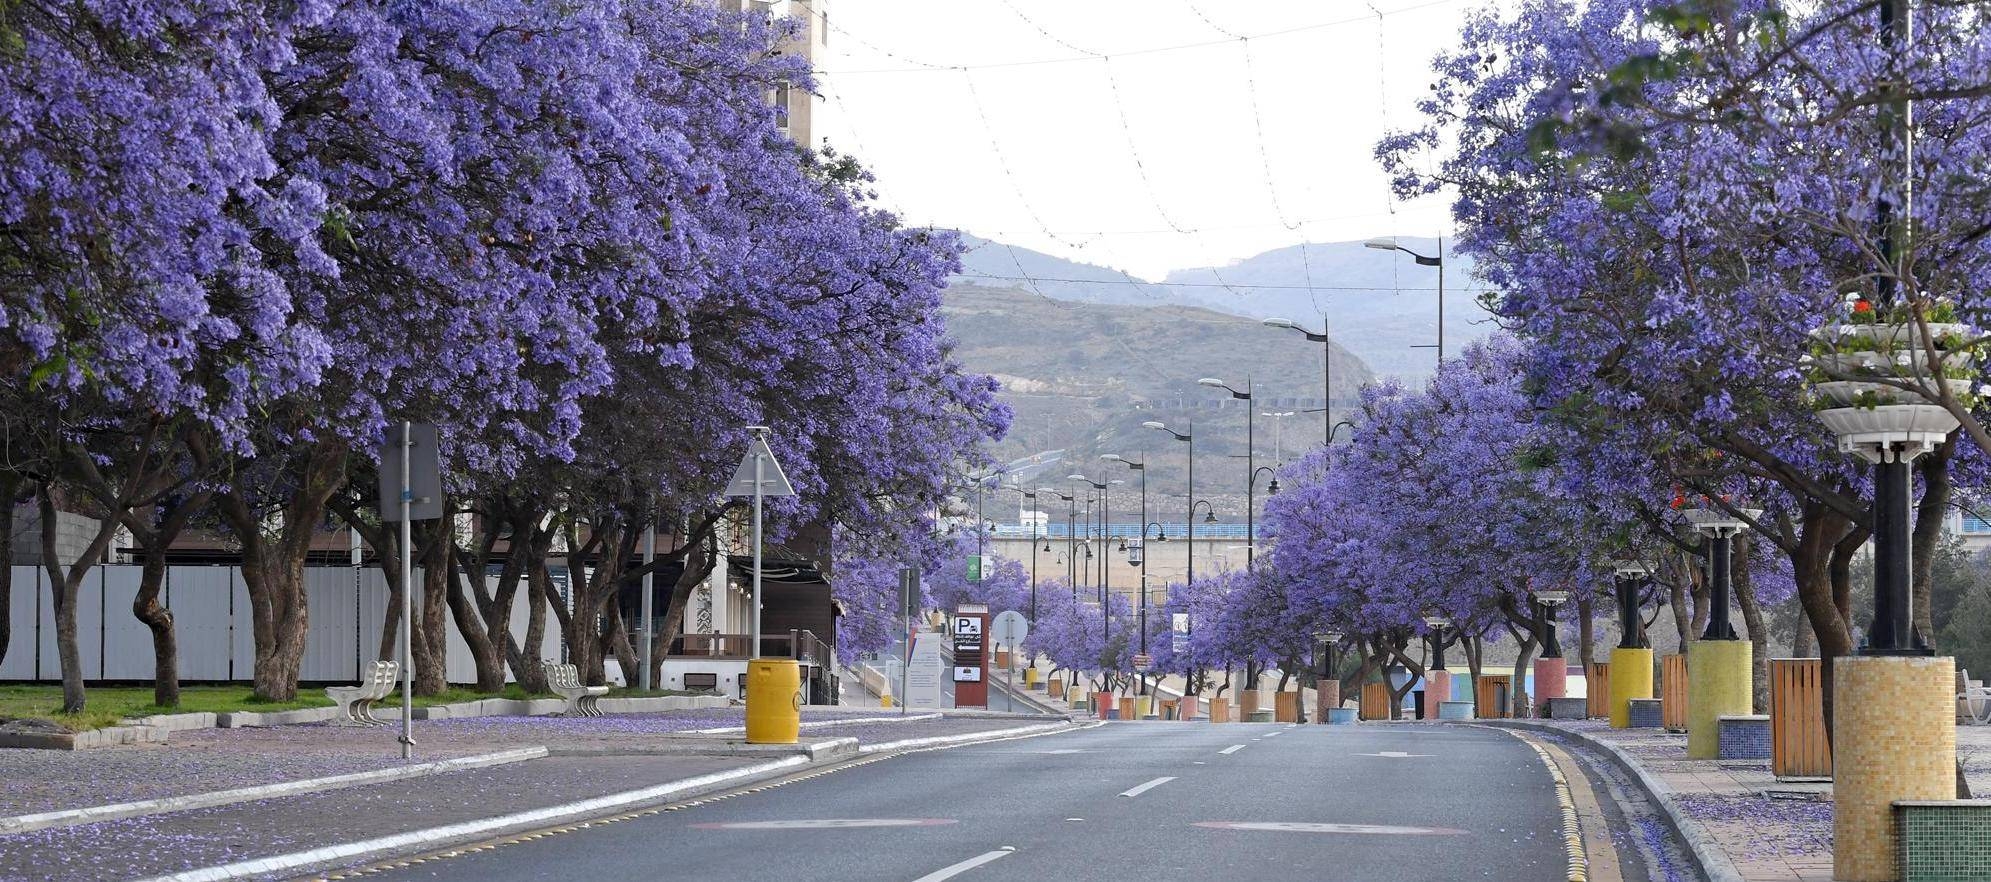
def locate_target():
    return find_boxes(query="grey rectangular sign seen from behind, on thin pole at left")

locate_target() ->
[380,420,442,759]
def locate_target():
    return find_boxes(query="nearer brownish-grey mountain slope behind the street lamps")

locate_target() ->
[942,280,1374,520]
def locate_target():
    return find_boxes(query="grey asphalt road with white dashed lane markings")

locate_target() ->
[358,723,1567,882]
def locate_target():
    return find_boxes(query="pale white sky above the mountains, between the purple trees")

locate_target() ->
[816,0,1479,279]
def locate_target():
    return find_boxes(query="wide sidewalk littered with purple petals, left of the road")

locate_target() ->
[0,709,1063,880]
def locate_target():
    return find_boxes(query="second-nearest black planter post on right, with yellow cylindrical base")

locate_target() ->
[1680,508,1762,759]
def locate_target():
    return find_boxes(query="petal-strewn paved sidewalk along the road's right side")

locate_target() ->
[1517,721,1991,882]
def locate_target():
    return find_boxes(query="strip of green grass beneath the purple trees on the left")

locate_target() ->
[0,683,708,733]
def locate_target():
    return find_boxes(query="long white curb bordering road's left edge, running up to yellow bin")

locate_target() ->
[126,757,810,882]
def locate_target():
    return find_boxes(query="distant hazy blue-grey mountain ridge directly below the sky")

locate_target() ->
[956,235,1491,380]
